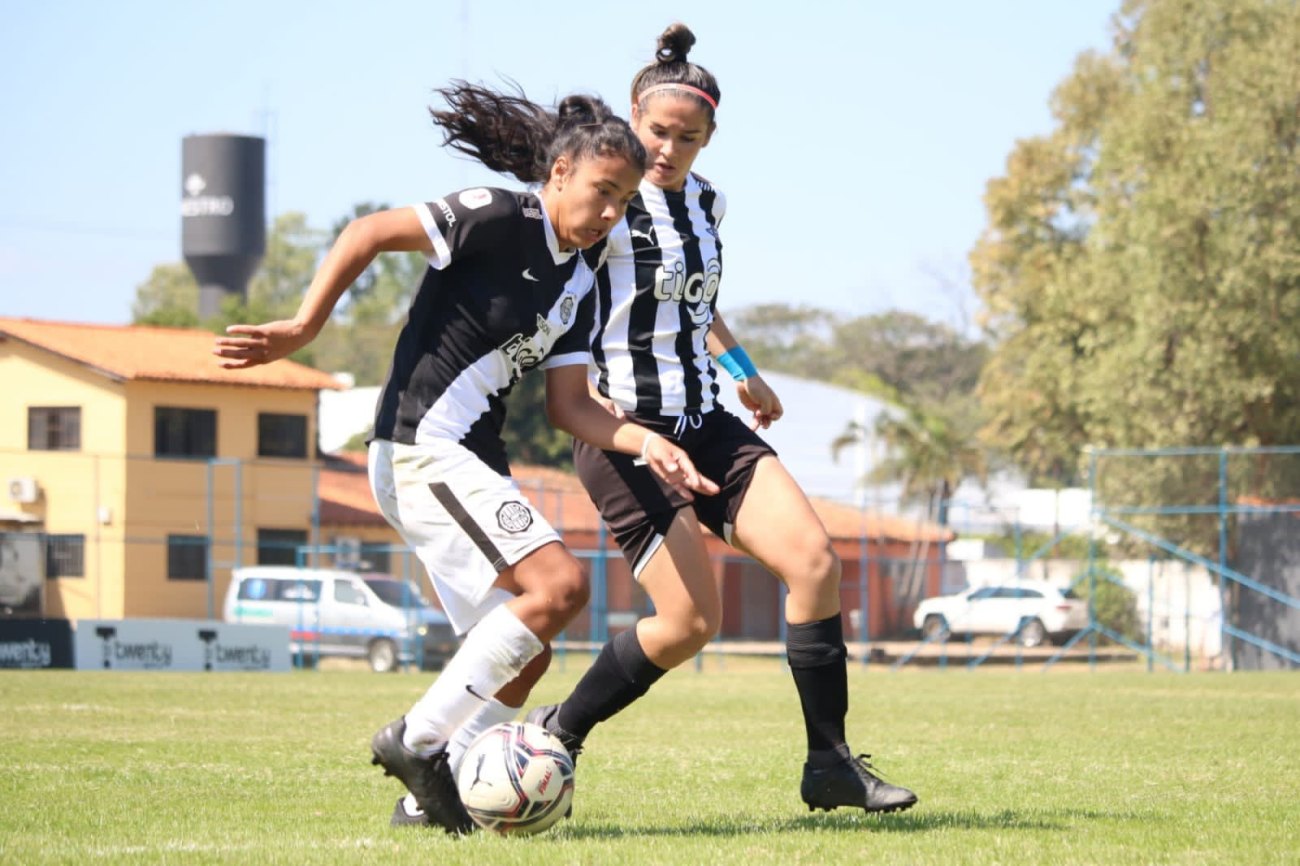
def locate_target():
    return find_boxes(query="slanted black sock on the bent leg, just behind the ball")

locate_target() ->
[555,628,667,737]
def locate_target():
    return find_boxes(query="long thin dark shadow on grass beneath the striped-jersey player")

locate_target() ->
[563,809,1138,839]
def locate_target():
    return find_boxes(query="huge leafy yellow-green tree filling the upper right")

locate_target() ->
[971,0,1300,529]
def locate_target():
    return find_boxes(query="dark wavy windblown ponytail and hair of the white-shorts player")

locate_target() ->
[429,81,646,183]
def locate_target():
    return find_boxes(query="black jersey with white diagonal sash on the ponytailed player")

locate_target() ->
[374,187,603,475]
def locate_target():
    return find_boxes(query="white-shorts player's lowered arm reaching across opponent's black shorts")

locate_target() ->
[546,364,718,499]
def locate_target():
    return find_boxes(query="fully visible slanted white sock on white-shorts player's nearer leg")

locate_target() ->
[403,605,542,755]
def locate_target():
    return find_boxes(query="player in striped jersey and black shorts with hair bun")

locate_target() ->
[528,23,917,811]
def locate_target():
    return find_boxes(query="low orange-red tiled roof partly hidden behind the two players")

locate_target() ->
[320,453,954,541]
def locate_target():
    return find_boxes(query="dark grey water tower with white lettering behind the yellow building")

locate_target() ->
[181,135,267,319]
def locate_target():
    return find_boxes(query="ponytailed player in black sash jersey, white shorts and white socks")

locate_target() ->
[215,83,718,832]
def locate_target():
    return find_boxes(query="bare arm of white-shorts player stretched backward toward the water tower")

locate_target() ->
[212,208,433,369]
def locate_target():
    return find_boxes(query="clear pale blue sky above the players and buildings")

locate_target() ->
[0,0,1119,325]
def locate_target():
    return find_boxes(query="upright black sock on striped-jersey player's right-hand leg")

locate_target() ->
[785,614,849,765]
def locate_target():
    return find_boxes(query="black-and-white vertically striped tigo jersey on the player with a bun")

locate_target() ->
[592,174,727,415]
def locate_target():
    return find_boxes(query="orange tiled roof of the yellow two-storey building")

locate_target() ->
[0,317,343,390]
